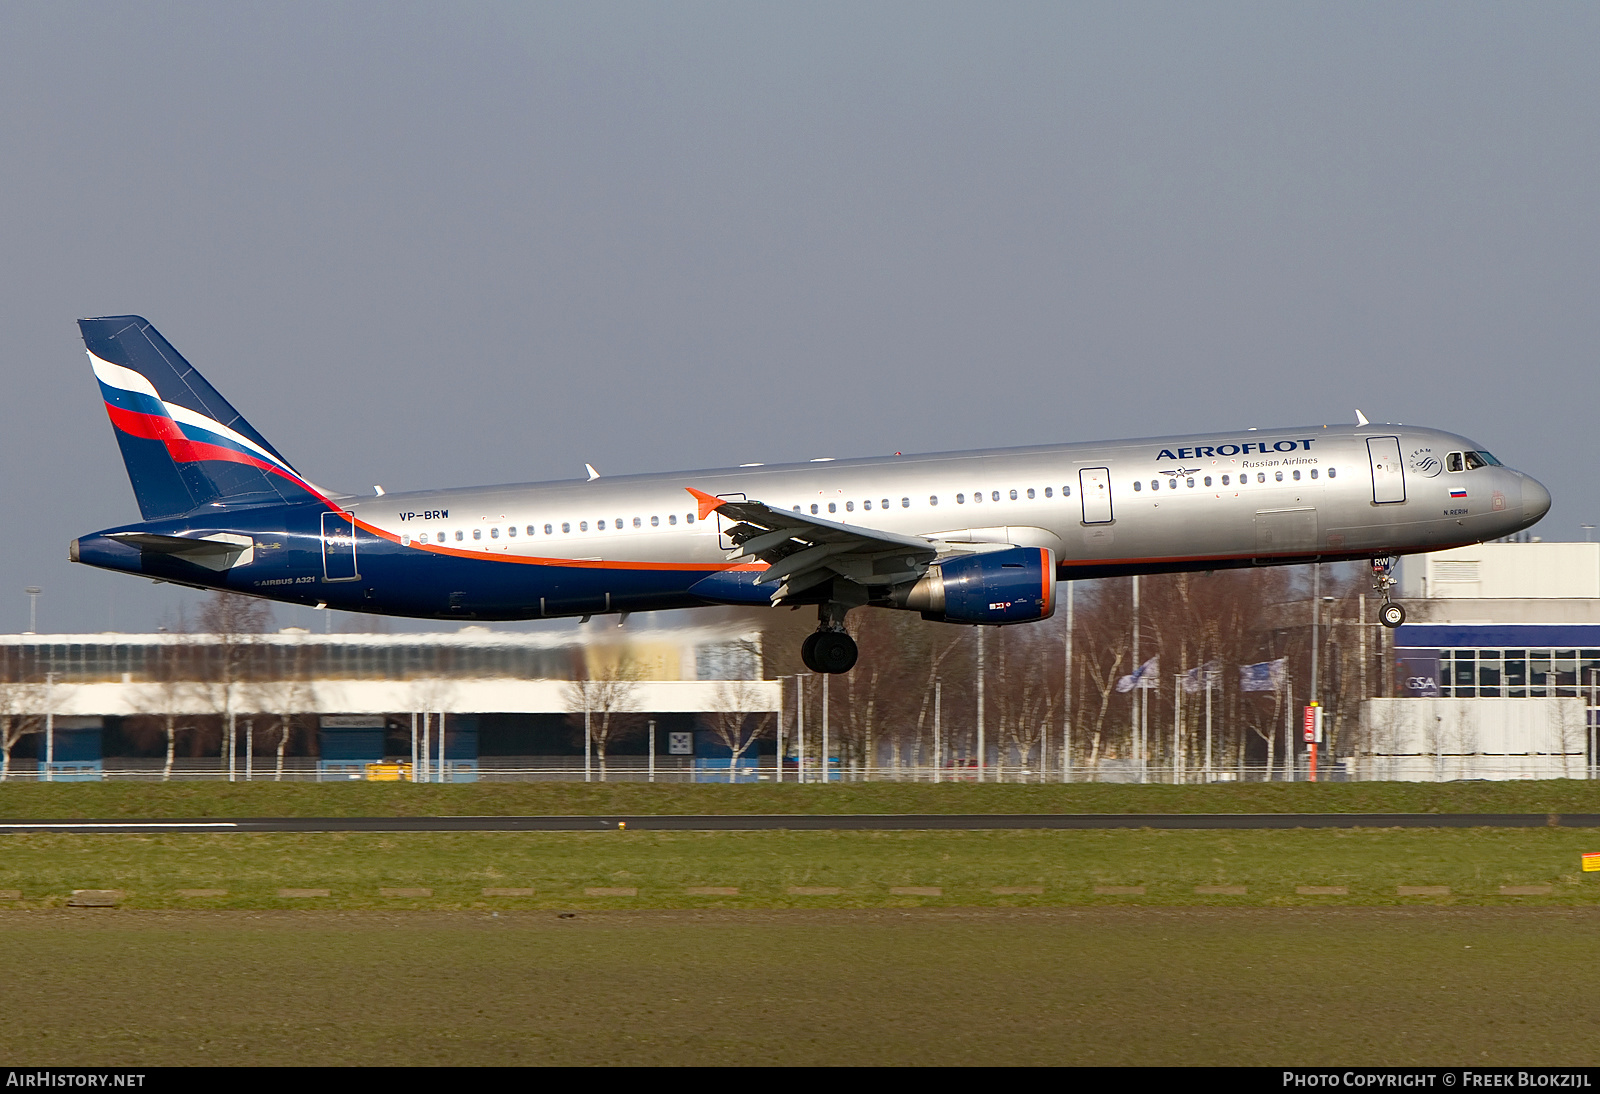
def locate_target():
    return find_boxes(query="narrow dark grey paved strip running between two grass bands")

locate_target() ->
[0,813,1600,833]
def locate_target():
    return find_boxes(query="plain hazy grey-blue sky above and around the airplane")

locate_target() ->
[0,3,1600,630]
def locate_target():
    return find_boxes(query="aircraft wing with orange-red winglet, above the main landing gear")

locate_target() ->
[688,488,941,605]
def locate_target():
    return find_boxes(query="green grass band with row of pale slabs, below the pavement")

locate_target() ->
[0,827,1600,910]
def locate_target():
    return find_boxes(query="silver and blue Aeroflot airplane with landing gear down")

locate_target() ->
[69,315,1550,673]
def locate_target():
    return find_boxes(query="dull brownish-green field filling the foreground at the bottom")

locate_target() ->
[0,908,1600,1068]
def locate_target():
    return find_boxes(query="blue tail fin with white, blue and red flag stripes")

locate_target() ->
[78,315,328,520]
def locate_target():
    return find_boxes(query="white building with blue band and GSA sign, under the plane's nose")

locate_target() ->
[1354,541,1600,779]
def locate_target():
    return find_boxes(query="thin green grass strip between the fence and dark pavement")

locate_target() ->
[0,779,1600,819]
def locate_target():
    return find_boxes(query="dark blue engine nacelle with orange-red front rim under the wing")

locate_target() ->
[891,547,1056,624]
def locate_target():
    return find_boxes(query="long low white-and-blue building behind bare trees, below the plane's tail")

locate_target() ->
[0,624,781,781]
